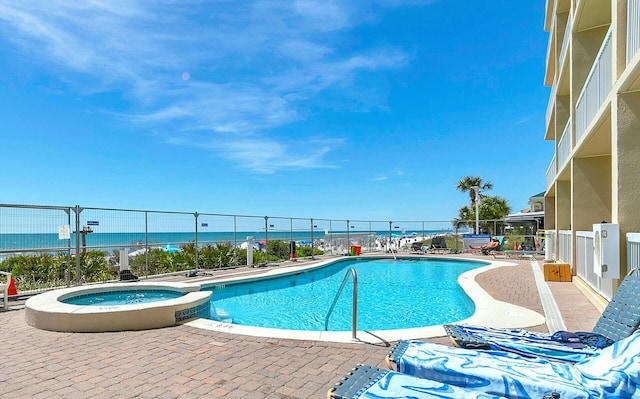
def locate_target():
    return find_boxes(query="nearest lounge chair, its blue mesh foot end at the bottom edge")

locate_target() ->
[327,364,503,399]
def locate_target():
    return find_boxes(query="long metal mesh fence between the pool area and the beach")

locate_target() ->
[0,204,482,288]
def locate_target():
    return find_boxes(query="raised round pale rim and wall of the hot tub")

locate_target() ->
[25,282,212,332]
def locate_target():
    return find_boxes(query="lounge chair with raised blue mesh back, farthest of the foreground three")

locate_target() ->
[444,271,640,362]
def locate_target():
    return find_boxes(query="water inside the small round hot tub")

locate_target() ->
[61,290,183,306]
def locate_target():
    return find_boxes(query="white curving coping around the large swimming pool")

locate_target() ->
[184,255,545,344]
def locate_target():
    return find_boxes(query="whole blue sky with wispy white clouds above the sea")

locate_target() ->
[0,0,553,220]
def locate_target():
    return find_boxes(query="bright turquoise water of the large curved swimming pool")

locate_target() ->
[209,258,488,331]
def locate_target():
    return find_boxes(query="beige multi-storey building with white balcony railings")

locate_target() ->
[544,0,640,297]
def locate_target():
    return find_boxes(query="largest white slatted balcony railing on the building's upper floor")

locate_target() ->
[575,28,613,143]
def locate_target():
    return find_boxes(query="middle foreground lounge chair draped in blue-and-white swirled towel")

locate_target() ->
[387,332,640,399]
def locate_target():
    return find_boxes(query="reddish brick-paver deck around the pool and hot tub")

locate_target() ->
[0,255,601,399]
